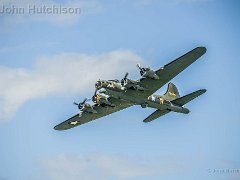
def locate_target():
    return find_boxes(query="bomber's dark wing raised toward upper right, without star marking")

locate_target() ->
[139,47,206,97]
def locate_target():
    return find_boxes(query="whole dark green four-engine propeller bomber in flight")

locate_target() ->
[54,47,206,130]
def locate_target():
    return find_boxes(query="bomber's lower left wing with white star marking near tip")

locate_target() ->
[54,97,133,130]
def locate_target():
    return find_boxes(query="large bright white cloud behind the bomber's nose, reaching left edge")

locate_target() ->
[0,51,143,121]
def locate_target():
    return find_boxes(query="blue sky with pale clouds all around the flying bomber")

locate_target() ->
[0,0,240,180]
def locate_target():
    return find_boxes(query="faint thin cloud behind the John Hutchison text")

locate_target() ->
[0,0,102,31]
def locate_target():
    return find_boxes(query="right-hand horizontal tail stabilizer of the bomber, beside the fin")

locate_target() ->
[172,89,207,106]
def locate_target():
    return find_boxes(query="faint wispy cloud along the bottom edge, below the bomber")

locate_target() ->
[42,154,154,180]
